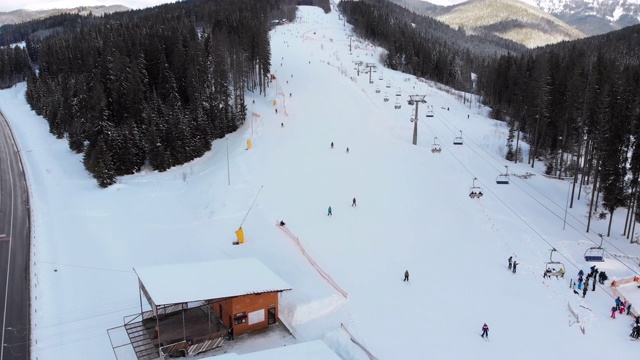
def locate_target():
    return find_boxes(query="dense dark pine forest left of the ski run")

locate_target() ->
[21,0,295,187]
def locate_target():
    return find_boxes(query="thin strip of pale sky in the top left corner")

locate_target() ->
[0,0,176,11]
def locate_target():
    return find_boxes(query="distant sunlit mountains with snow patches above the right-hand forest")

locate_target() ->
[390,0,640,47]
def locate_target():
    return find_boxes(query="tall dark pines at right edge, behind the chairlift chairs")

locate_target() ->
[478,26,640,233]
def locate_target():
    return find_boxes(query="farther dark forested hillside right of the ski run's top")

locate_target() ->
[339,0,525,91]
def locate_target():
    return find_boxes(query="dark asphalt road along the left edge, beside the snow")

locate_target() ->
[0,113,30,360]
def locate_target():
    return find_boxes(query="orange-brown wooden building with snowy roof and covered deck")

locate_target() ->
[125,258,291,359]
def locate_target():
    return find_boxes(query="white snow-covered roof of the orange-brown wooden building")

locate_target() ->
[133,258,291,305]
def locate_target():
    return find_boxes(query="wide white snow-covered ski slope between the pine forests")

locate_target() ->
[0,2,640,360]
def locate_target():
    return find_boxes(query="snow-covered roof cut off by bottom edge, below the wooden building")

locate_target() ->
[204,340,340,360]
